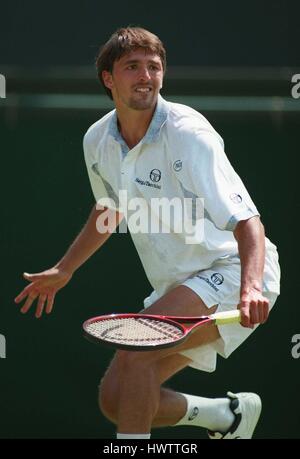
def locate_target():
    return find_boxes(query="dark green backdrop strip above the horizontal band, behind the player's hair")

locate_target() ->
[0,0,299,66]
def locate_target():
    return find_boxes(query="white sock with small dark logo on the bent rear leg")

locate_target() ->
[175,394,235,433]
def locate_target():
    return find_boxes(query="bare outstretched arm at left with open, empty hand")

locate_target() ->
[15,207,123,318]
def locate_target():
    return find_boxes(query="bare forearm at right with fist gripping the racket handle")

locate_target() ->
[234,217,269,328]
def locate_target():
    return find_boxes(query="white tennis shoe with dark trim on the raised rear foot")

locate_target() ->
[207,392,261,440]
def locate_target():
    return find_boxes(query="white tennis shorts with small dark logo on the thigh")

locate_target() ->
[144,251,280,372]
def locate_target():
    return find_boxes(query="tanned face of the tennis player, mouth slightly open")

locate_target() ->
[102,48,163,110]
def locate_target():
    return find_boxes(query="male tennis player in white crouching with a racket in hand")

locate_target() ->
[16,27,280,439]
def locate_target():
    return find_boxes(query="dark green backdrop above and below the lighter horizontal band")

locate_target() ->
[0,1,300,438]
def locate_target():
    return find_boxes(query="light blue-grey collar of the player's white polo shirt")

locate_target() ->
[108,94,169,146]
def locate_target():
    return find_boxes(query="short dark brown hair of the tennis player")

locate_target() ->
[96,27,166,99]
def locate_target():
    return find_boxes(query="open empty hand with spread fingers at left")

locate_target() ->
[15,267,72,318]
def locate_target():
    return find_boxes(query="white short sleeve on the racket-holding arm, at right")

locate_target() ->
[178,133,259,231]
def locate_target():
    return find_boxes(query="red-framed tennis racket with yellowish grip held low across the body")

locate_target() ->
[83,309,240,351]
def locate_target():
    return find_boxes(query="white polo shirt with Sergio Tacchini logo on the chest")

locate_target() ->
[84,96,276,297]
